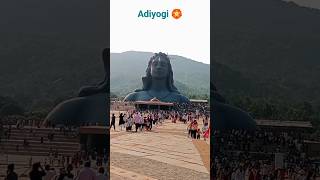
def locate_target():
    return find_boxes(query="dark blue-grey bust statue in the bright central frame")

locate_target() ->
[124,52,189,103]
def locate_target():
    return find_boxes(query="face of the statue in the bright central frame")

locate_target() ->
[151,57,169,79]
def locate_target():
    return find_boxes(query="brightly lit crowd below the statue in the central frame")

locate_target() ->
[110,104,210,140]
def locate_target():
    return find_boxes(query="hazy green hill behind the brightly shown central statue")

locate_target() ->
[110,51,210,97]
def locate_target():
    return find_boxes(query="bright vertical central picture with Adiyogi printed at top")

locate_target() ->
[110,0,210,180]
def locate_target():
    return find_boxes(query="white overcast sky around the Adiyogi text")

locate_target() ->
[110,0,210,64]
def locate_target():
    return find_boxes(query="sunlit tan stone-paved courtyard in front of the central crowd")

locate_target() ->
[110,120,210,180]
